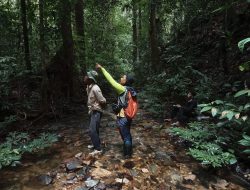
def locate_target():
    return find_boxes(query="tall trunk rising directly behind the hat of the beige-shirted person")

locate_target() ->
[75,0,86,73]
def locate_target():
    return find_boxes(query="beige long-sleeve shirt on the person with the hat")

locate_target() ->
[86,84,106,113]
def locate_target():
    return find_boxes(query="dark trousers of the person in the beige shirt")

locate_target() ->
[89,111,102,150]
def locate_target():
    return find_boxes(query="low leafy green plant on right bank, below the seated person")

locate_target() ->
[170,122,237,167]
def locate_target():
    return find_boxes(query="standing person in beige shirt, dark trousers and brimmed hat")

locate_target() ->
[84,71,106,156]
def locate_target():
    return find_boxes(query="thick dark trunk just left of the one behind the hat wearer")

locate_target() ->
[59,0,74,98]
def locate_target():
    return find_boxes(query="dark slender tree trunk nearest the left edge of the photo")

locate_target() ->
[21,0,32,70]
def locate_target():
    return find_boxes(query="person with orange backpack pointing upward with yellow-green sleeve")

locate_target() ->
[96,64,138,158]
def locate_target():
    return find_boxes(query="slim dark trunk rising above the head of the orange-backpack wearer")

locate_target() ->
[132,0,138,65]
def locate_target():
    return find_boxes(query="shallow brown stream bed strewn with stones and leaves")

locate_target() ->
[0,110,247,190]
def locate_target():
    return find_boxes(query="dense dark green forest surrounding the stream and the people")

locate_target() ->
[0,0,250,189]
